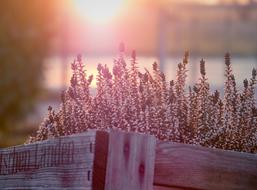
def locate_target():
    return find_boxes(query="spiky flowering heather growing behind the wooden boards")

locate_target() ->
[29,45,257,153]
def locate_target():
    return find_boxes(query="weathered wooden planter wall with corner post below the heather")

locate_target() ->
[0,131,257,190]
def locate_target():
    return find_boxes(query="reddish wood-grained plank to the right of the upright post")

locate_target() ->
[154,141,257,190]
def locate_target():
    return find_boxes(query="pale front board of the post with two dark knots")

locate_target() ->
[105,131,156,190]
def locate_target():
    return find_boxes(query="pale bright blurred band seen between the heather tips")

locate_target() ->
[44,56,257,90]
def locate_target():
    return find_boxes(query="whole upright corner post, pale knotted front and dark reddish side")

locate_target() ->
[93,131,156,190]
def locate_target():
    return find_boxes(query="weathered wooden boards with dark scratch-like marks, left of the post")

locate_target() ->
[0,132,95,190]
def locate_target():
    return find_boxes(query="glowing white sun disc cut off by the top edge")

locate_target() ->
[74,0,125,24]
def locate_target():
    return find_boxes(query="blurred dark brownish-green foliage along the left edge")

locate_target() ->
[0,0,57,140]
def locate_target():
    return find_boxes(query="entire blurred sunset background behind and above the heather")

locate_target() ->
[0,0,257,147]
